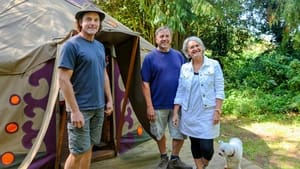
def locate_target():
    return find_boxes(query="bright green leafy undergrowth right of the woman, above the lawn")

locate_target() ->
[223,47,300,116]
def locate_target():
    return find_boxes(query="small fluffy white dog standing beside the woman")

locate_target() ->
[219,137,243,169]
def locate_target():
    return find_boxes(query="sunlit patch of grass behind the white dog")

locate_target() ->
[219,114,300,169]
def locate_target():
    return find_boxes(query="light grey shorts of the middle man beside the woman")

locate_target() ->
[150,109,187,140]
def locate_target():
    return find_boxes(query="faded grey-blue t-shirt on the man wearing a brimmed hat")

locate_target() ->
[59,35,106,110]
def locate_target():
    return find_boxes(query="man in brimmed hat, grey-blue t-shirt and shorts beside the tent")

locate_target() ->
[58,5,113,169]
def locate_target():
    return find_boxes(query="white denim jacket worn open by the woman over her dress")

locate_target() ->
[174,56,225,110]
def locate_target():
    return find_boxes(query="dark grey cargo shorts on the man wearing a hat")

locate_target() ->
[68,108,104,154]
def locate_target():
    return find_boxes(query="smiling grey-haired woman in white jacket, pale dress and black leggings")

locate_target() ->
[172,36,225,169]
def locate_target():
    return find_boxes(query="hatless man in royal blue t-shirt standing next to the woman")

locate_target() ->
[141,26,192,169]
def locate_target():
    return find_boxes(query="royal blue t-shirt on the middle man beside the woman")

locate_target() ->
[141,49,184,109]
